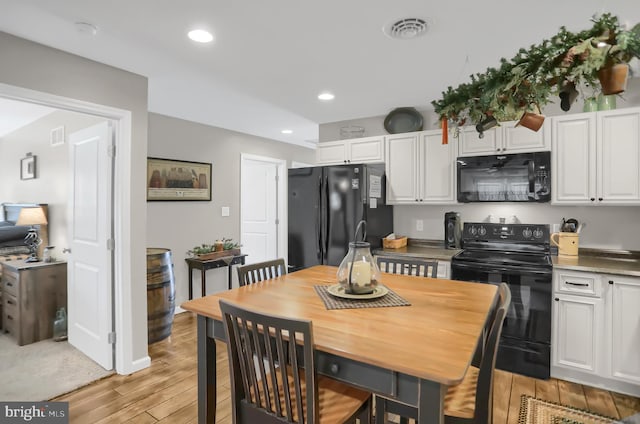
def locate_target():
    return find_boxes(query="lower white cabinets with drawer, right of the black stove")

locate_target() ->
[551,269,640,396]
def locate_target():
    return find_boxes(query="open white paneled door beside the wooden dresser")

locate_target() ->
[67,121,114,369]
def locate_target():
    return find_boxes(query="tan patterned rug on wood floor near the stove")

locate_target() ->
[518,395,619,424]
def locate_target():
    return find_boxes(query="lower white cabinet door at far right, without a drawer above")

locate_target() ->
[604,275,640,385]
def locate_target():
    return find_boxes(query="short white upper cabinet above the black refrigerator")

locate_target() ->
[316,136,384,165]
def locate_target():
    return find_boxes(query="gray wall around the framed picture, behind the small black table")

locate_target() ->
[147,113,315,305]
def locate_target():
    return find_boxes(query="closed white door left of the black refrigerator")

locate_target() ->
[240,155,286,263]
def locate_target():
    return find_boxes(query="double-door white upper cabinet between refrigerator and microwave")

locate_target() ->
[385,130,456,204]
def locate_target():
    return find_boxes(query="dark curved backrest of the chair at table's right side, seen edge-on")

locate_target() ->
[474,283,511,423]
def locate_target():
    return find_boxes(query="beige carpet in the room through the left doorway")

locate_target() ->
[0,334,113,401]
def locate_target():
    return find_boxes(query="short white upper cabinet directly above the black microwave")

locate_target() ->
[458,121,551,156]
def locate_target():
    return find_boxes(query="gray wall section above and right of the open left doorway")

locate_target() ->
[0,32,148,365]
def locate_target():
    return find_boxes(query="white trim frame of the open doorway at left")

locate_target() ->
[0,84,145,374]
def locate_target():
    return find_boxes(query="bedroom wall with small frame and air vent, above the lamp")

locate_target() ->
[0,110,104,255]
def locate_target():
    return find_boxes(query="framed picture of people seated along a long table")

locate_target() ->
[147,158,212,201]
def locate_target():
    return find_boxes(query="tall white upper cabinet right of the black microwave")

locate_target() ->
[551,108,640,205]
